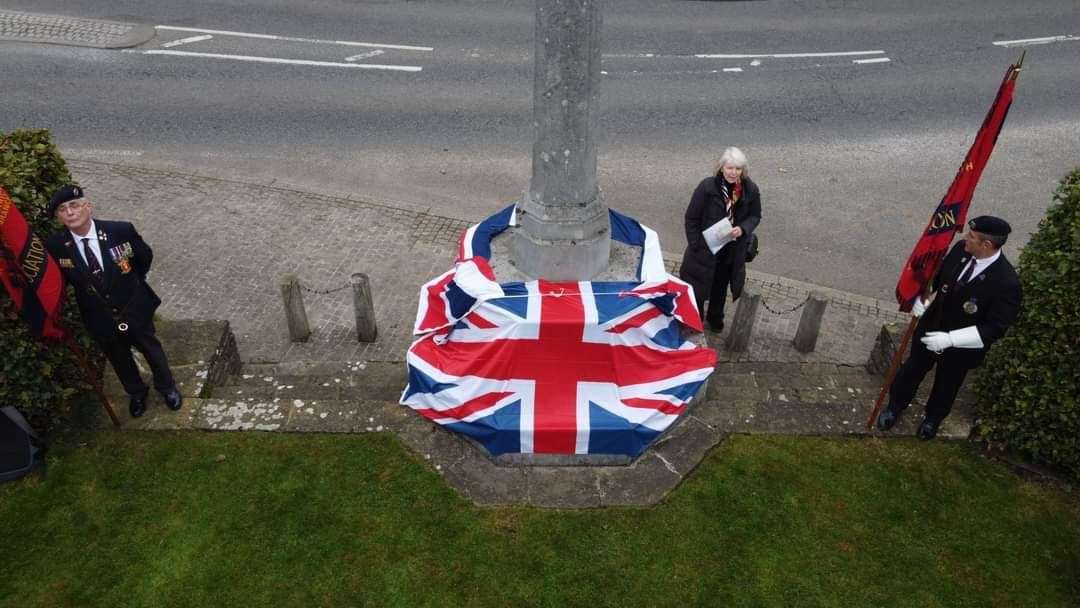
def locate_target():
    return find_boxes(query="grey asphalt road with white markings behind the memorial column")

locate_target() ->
[0,0,1080,298]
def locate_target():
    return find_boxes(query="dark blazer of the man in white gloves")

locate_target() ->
[914,241,1021,369]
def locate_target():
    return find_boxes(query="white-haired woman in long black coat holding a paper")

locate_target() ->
[679,148,761,333]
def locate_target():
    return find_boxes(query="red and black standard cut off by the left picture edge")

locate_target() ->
[0,188,65,339]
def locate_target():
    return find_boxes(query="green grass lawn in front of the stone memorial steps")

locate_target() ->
[0,431,1080,608]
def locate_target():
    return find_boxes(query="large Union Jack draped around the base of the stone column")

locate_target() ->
[401,207,716,456]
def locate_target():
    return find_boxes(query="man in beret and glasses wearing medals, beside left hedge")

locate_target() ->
[45,186,183,418]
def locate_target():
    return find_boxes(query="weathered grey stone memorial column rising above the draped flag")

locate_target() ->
[512,0,611,281]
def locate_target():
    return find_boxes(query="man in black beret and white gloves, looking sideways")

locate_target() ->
[877,215,1021,440]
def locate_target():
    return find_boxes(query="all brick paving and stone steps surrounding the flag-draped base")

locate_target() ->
[69,160,971,508]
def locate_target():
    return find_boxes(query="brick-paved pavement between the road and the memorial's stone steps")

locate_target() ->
[69,160,901,365]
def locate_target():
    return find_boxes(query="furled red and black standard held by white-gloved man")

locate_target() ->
[896,55,1024,312]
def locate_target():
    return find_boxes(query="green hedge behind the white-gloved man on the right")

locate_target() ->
[975,168,1080,476]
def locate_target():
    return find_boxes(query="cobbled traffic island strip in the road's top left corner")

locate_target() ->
[0,10,154,49]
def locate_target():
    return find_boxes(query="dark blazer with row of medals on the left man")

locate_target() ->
[45,219,161,342]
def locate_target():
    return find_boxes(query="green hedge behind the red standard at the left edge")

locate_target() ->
[0,130,94,430]
